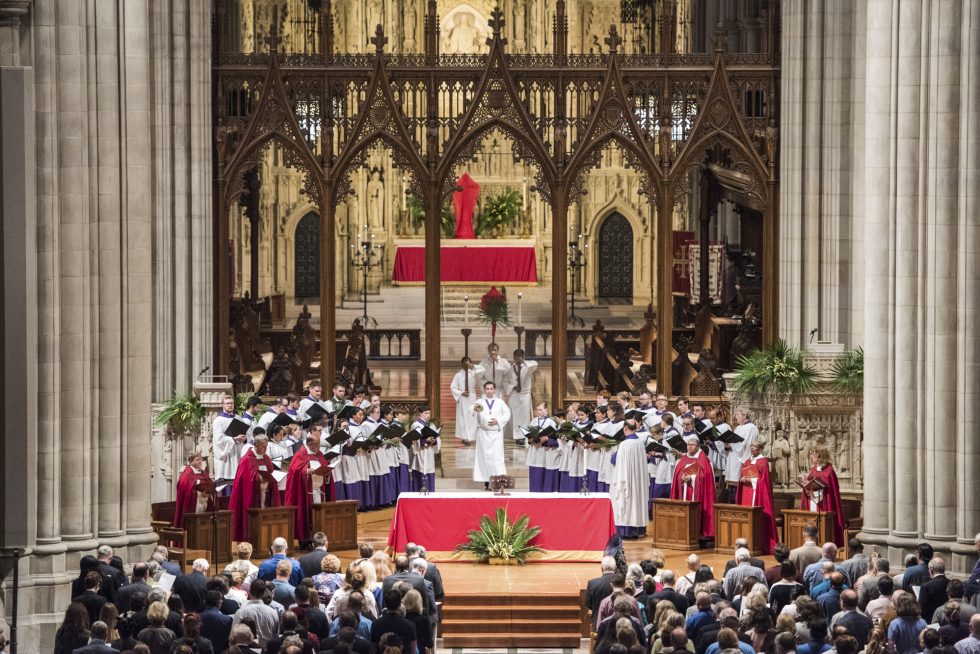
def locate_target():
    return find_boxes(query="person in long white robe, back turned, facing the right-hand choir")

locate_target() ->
[609,418,650,538]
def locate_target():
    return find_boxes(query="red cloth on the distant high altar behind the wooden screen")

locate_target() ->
[391,246,538,283]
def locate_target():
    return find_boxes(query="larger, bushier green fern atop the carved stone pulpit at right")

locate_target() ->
[735,339,819,395]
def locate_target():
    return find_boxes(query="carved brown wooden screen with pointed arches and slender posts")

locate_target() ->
[213,0,779,416]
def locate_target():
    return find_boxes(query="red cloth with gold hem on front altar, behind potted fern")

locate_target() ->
[388,493,616,561]
